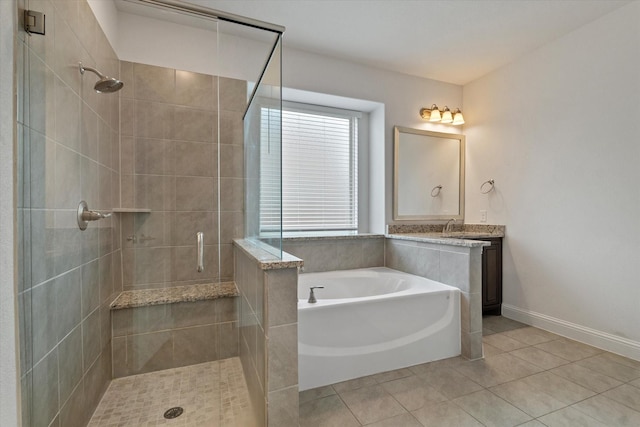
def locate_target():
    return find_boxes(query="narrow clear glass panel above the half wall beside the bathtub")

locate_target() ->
[244,37,282,257]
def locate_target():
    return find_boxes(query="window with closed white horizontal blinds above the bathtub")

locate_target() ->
[260,103,360,233]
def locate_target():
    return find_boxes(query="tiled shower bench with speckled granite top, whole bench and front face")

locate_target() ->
[111,282,239,378]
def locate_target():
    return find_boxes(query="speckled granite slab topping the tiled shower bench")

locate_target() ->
[111,282,239,310]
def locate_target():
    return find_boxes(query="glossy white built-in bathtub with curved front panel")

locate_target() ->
[298,267,460,390]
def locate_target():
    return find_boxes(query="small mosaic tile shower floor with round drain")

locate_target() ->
[89,357,250,427]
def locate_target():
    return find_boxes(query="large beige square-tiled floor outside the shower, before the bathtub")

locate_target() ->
[300,316,640,427]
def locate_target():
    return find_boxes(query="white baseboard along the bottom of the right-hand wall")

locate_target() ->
[502,304,640,361]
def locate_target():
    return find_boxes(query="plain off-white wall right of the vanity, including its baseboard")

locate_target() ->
[464,1,640,360]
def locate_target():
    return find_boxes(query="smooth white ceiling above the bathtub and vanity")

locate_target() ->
[169,0,624,85]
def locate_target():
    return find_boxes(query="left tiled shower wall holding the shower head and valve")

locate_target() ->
[18,0,120,426]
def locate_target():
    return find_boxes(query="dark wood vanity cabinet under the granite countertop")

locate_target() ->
[478,237,502,315]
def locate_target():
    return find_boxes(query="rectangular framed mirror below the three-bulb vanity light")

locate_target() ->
[393,126,465,221]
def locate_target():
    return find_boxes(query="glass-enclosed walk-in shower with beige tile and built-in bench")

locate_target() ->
[16,0,283,427]
